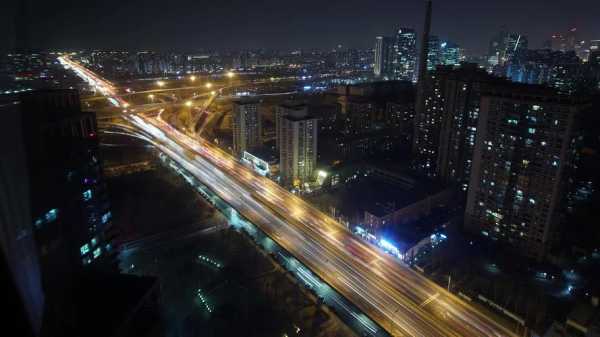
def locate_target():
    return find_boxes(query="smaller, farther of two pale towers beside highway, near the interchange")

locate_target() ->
[232,100,262,156]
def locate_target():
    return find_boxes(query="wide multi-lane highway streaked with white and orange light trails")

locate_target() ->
[61,58,515,337]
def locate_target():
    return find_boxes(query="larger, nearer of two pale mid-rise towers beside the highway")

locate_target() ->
[279,104,318,187]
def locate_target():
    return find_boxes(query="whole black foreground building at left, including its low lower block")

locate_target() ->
[0,90,159,336]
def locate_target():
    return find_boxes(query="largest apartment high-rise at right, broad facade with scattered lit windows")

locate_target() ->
[465,84,582,259]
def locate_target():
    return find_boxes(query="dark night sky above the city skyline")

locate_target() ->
[0,0,600,54]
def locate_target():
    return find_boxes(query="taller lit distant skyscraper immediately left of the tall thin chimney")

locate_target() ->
[393,28,417,81]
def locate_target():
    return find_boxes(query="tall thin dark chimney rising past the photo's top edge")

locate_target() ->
[413,0,431,153]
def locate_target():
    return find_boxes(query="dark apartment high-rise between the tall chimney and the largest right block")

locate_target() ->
[413,63,506,181]
